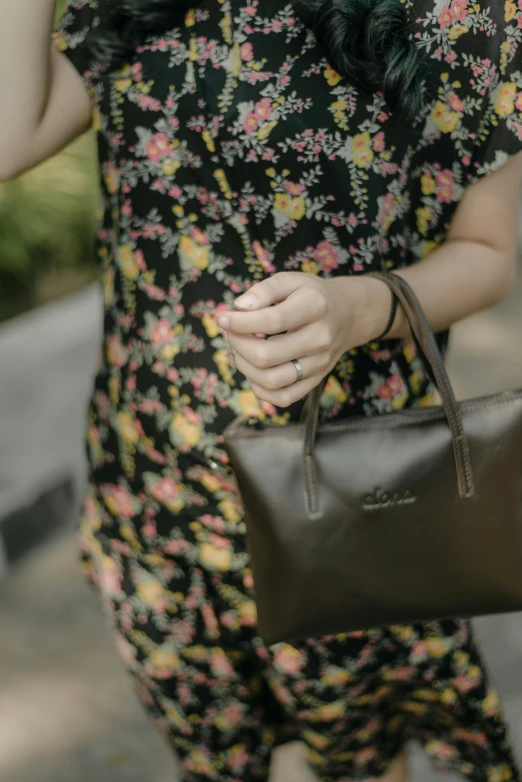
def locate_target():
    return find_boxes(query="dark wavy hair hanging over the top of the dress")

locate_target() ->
[93,0,424,120]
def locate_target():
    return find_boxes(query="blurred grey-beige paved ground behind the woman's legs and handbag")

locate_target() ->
[0,282,522,782]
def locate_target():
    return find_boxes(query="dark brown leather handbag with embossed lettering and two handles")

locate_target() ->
[225,273,522,644]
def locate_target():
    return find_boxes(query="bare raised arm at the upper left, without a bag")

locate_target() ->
[0,0,91,181]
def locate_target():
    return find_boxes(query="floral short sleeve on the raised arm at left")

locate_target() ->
[53,0,100,86]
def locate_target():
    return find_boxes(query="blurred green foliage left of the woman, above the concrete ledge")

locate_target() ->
[0,0,98,320]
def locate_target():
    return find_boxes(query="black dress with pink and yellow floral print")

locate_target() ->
[55,0,522,782]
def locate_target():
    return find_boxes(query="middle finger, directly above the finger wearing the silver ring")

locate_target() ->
[228,322,332,369]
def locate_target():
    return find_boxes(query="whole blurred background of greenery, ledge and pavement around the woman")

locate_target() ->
[0,3,522,782]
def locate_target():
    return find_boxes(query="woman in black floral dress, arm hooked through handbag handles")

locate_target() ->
[0,0,522,782]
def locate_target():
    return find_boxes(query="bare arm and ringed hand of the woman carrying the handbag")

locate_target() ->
[219,154,522,407]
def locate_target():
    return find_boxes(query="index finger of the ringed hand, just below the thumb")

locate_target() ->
[219,280,326,334]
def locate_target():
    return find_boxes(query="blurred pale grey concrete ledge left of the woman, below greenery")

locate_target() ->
[0,285,102,573]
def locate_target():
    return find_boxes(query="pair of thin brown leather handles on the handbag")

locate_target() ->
[303,272,475,518]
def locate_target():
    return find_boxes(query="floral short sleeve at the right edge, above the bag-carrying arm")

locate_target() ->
[468,0,522,183]
